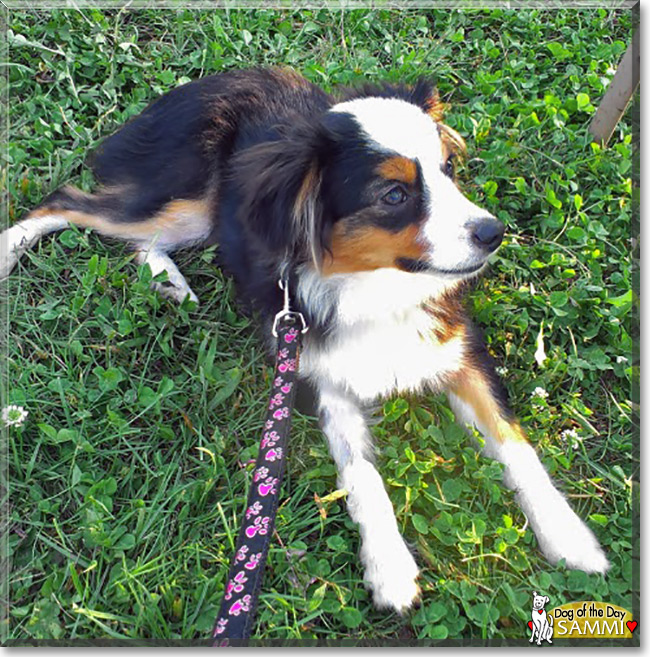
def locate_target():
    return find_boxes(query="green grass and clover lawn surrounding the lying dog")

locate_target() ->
[2,9,639,645]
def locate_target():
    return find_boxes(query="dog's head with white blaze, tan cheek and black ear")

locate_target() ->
[233,83,504,287]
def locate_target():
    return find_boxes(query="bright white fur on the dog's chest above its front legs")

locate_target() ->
[300,308,463,401]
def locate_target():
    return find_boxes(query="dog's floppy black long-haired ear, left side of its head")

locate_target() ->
[234,123,325,266]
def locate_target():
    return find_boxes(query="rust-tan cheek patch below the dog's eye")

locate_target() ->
[322,222,425,276]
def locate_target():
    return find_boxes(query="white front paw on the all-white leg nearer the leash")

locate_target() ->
[361,537,420,614]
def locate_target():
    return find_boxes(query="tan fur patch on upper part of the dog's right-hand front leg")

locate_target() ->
[450,370,528,443]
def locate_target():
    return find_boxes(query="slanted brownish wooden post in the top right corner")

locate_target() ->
[589,28,641,146]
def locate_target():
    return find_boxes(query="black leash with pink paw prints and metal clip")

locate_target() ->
[212,278,308,647]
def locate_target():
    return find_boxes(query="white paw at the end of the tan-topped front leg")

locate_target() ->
[522,490,610,574]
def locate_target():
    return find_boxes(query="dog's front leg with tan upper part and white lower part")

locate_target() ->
[448,359,609,573]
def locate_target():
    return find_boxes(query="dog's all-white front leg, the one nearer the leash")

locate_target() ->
[319,384,419,613]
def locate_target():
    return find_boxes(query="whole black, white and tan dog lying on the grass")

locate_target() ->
[0,69,609,612]
